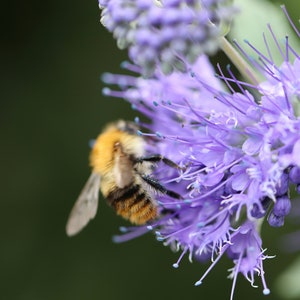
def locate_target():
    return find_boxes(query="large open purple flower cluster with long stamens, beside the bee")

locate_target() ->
[98,0,300,299]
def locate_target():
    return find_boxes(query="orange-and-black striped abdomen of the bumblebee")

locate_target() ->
[106,183,157,225]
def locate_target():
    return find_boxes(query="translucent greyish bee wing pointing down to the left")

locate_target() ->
[66,173,100,236]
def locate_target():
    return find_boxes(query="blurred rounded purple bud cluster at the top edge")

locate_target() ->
[99,0,236,75]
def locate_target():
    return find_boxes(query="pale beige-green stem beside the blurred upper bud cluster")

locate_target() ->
[220,37,261,85]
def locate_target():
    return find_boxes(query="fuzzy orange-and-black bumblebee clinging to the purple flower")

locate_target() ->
[66,120,181,236]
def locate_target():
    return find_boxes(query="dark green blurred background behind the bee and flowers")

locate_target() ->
[0,0,299,300]
